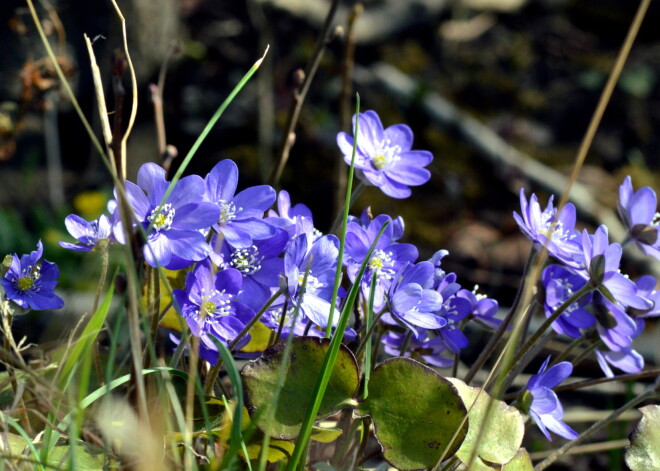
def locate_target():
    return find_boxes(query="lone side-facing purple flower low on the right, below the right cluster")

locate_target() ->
[527,357,578,441]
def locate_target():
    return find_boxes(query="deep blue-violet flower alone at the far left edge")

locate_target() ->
[0,241,64,311]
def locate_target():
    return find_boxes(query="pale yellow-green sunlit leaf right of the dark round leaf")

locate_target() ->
[447,378,525,469]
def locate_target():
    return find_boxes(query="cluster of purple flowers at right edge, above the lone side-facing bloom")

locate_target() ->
[513,181,660,377]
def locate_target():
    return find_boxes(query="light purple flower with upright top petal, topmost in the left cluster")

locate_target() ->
[205,159,275,249]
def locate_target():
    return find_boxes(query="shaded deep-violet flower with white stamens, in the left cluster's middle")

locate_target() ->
[211,228,289,311]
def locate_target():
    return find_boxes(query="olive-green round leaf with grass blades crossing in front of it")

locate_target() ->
[241,337,359,440]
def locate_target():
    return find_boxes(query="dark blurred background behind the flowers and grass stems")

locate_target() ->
[0,0,660,469]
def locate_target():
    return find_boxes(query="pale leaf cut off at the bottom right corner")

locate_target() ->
[626,405,660,471]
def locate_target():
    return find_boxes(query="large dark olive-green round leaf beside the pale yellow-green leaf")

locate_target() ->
[356,358,468,470]
